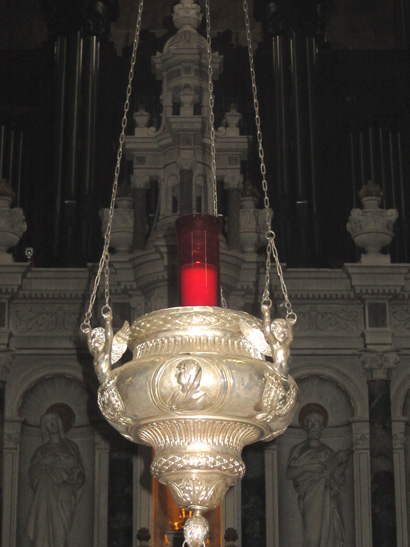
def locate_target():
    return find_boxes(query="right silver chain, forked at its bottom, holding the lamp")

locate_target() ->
[243,0,297,324]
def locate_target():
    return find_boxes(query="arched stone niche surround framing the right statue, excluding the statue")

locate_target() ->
[276,364,371,547]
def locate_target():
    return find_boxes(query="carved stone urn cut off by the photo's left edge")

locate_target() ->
[0,179,27,264]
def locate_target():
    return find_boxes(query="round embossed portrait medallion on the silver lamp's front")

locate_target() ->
[150,355,228,414]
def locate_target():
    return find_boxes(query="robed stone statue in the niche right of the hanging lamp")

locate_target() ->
[286,403,351,547]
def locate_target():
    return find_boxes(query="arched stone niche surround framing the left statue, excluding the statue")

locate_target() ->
[3,357,105,547]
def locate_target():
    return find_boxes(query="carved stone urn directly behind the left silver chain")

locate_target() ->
[100,188,134,259]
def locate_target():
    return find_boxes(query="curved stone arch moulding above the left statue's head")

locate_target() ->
[5,362,84,418]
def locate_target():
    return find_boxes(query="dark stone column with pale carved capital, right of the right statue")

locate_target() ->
[361,351,398,547]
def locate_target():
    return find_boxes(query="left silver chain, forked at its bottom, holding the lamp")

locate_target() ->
[80,0,144,333]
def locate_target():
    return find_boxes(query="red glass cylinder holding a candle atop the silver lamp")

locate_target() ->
[176,215,219,306]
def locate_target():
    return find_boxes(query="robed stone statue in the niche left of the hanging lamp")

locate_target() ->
[25,412,85,547]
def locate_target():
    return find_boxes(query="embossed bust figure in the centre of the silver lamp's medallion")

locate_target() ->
[168,359,210,411]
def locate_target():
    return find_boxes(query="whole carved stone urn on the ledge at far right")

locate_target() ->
[346,182,398,264]
